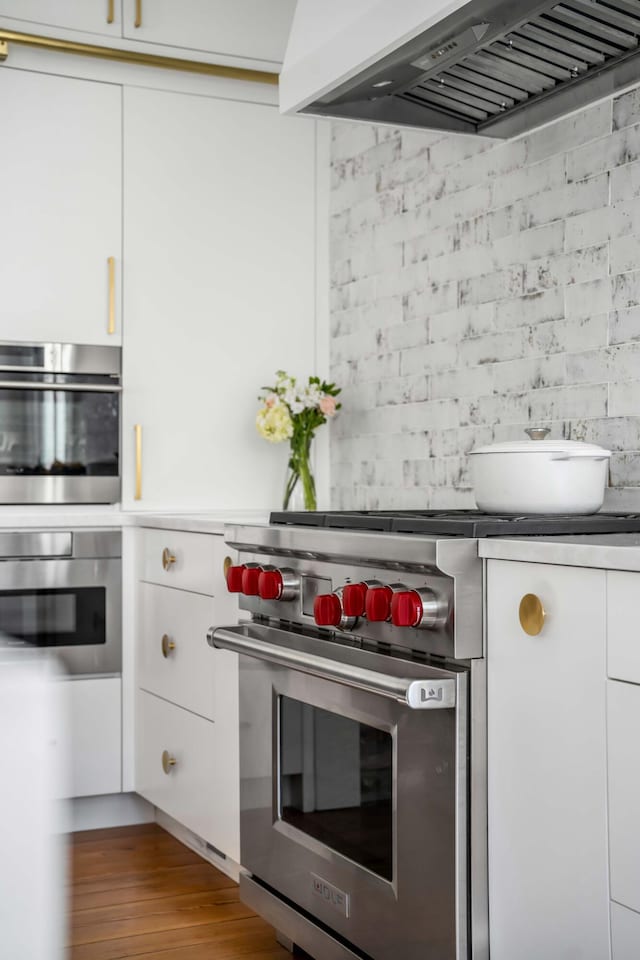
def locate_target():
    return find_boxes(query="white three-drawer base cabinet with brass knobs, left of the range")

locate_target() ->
[135,529,240,862]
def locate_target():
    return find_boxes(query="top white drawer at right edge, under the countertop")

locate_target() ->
[607,570,640,683]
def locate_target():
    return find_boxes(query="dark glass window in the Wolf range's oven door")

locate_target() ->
[278,696,393,880]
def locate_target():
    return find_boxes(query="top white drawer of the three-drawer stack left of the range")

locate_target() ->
[142,530,229,597]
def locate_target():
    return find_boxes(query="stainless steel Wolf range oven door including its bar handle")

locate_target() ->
[212,623,468,960]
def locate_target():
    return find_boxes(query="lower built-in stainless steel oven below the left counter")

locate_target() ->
[0,530,122,676]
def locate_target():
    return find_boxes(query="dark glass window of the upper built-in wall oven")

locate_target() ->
[0,374,119,477]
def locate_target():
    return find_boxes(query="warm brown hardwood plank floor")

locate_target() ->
[69,824,291,960]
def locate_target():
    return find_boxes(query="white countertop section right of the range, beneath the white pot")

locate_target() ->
[478,533,640,570]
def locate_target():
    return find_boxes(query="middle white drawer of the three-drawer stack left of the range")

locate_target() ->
[137,583,231,720]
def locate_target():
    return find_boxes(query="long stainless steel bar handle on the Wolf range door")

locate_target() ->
[207,624,456,710]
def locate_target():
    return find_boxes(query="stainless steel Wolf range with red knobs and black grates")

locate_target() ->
[208,511,640,960]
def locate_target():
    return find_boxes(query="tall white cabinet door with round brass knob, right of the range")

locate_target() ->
[487,560,609,960]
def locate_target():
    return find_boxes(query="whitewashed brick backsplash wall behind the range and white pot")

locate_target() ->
[331,88,640,510]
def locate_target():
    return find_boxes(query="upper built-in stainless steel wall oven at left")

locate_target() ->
[0,342,121,503]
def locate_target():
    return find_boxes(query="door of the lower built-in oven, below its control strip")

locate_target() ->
[0,557,122,675]
